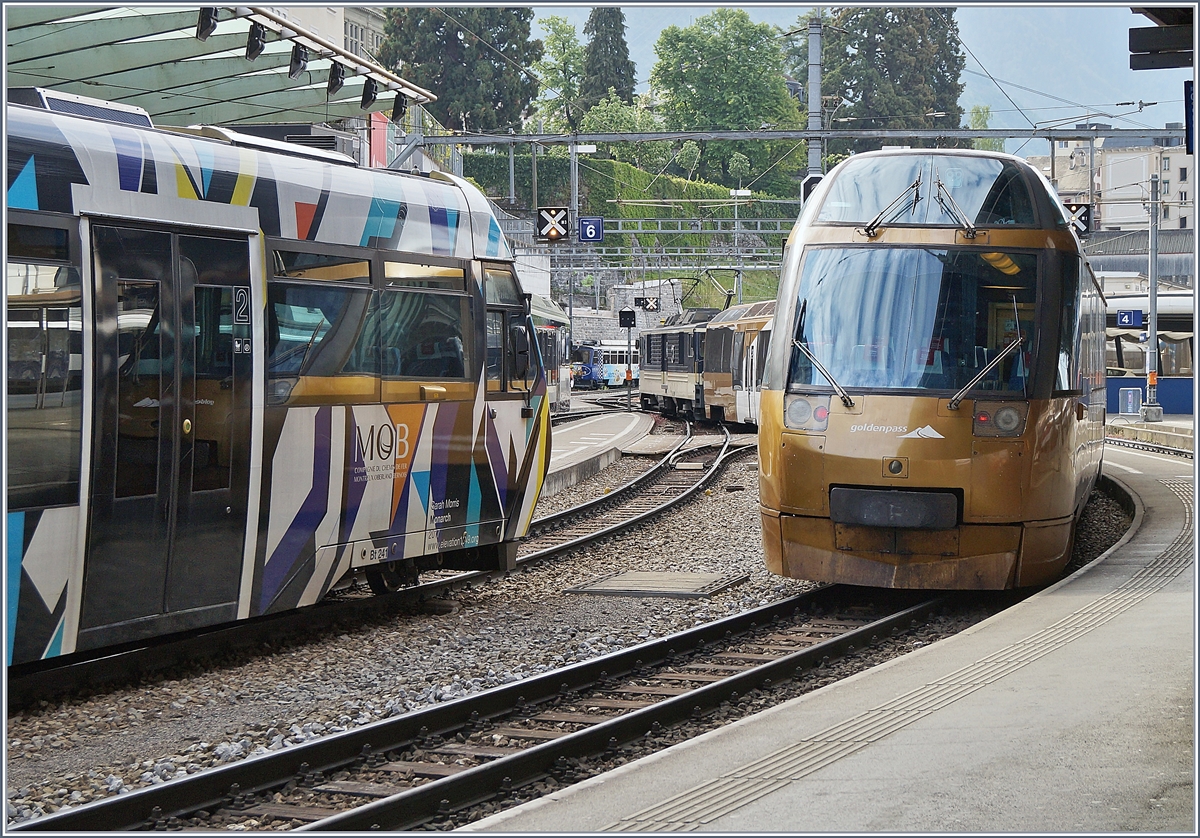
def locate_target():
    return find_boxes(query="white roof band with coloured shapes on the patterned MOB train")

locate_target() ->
[5,104,512,261]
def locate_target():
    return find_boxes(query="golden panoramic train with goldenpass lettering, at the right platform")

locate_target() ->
[758,149,1105,589]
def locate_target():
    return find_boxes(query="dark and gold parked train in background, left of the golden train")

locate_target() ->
[638,300,775,425]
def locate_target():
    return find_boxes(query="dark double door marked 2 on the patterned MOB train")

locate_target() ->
[77,225,252,650]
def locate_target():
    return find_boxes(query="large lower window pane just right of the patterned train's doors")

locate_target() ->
[266,282,379,403]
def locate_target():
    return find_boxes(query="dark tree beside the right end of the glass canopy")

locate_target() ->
[379,6,542,131]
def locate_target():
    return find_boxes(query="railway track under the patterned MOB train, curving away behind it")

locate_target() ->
[7,429,752,712]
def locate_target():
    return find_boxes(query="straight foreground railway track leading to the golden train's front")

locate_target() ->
[12,586,942,832]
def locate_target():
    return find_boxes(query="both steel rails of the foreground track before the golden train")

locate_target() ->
[10,586,941,832]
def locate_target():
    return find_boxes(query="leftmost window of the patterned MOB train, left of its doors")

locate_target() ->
[5,237,83,510]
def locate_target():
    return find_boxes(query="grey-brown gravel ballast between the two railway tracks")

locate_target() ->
[6,457,1128,822]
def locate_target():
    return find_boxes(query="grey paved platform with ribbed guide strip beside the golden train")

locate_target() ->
[462,447,1196,834]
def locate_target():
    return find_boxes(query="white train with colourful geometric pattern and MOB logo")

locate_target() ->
[5,91,550,665]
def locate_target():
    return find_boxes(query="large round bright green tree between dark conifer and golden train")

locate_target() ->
[650,8,800,193]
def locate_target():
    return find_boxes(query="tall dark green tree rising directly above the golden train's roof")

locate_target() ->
[787,6,966,151]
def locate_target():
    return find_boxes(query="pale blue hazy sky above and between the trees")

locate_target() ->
[533,4,1193,155]
